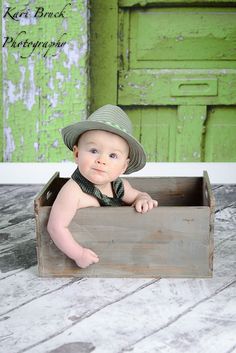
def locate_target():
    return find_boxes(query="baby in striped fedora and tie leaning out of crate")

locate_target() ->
[47,104,158,268]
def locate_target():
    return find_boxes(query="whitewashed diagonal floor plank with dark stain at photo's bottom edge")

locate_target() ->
[17,279,236,353]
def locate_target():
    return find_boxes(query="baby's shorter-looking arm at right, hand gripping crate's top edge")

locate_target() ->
[123,180,158,213]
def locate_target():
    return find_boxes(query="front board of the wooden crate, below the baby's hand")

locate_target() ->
[38,207,211,277]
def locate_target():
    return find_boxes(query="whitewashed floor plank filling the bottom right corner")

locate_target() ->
[119,281,236,353]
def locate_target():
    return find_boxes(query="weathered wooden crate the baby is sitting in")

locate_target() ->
[35,172,215,277]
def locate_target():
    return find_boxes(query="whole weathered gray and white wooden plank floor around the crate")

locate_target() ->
[0,185,236,353]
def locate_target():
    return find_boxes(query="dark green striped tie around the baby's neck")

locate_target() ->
[71,168,124,206]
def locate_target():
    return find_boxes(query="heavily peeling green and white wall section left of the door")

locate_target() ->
[1,0,88,162]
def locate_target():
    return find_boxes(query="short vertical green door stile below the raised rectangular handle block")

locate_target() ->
[176,106,206,162]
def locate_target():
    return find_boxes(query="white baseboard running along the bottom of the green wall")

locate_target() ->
[0,162,236,184]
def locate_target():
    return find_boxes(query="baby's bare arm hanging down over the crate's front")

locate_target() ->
[47,180,99,268]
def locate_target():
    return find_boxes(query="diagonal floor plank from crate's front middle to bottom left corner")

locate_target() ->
[0,279,157,353]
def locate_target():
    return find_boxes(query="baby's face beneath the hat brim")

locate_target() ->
[74,130,129,185]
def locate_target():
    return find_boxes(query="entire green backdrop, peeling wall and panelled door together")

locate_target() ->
[3,0,236,162]
